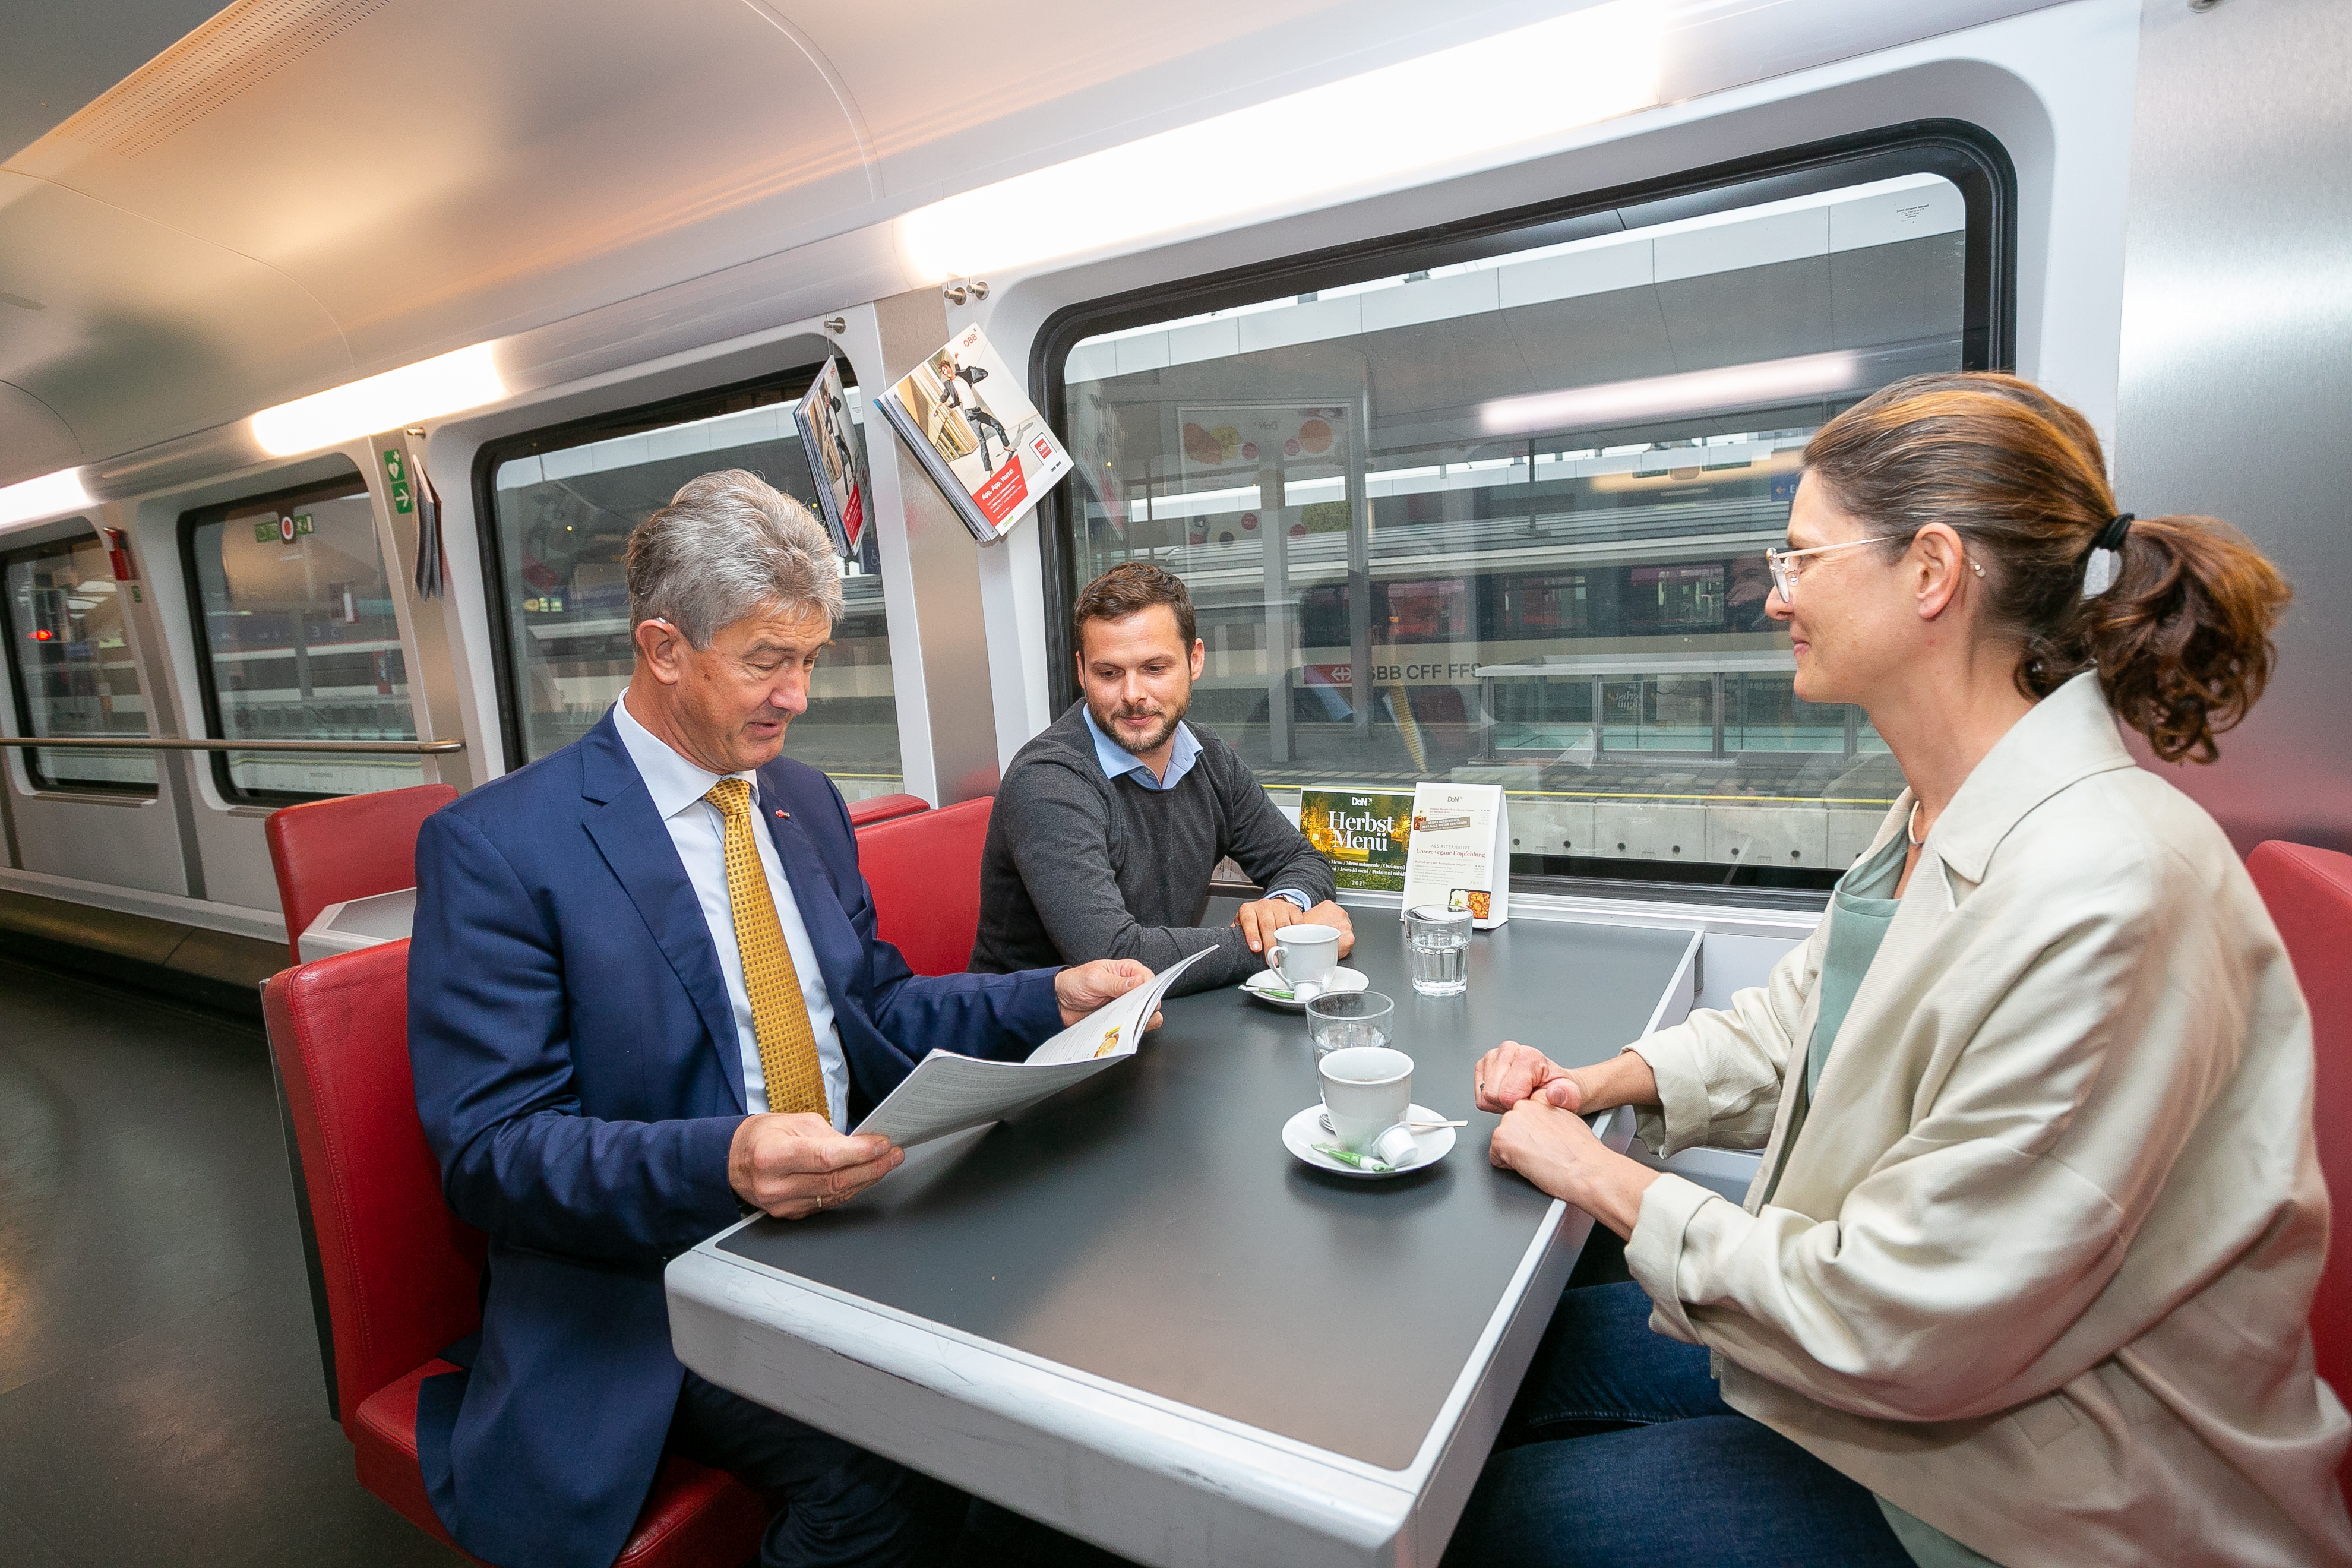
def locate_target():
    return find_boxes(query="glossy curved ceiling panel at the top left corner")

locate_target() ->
[12,0,870,369]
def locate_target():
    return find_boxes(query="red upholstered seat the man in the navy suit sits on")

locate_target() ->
[261,940,767,1568]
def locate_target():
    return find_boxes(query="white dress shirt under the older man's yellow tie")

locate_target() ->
[612,698,849,1131]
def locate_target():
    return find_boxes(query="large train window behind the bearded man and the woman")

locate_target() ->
[1044,128,2006,889]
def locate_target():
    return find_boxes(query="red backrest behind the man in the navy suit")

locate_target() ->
[261,943,485,1434]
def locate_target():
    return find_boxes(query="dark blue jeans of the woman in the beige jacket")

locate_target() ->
[1446,1284,1912,1568]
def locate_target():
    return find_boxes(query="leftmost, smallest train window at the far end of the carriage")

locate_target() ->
[0,536,155,795]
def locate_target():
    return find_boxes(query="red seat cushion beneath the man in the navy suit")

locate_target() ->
[350,1361,767,1568]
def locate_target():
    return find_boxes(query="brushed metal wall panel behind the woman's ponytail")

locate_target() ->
[2114,0,2352,851]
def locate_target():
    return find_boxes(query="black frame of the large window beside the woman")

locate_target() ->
[1028,120,2018,908]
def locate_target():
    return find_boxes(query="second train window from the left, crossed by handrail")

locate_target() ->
[179,475,423,804]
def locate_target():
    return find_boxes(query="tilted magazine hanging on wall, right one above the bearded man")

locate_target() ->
[875,327,1075,543]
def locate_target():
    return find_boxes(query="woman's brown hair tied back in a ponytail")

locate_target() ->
[1804,371,2291,761]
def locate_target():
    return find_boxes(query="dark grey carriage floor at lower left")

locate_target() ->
[0,962,461,1568]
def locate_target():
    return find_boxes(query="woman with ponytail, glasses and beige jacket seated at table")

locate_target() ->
[1446,374,2352,1568]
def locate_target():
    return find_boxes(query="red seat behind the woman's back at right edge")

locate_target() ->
[2246,839,2352,1488]
